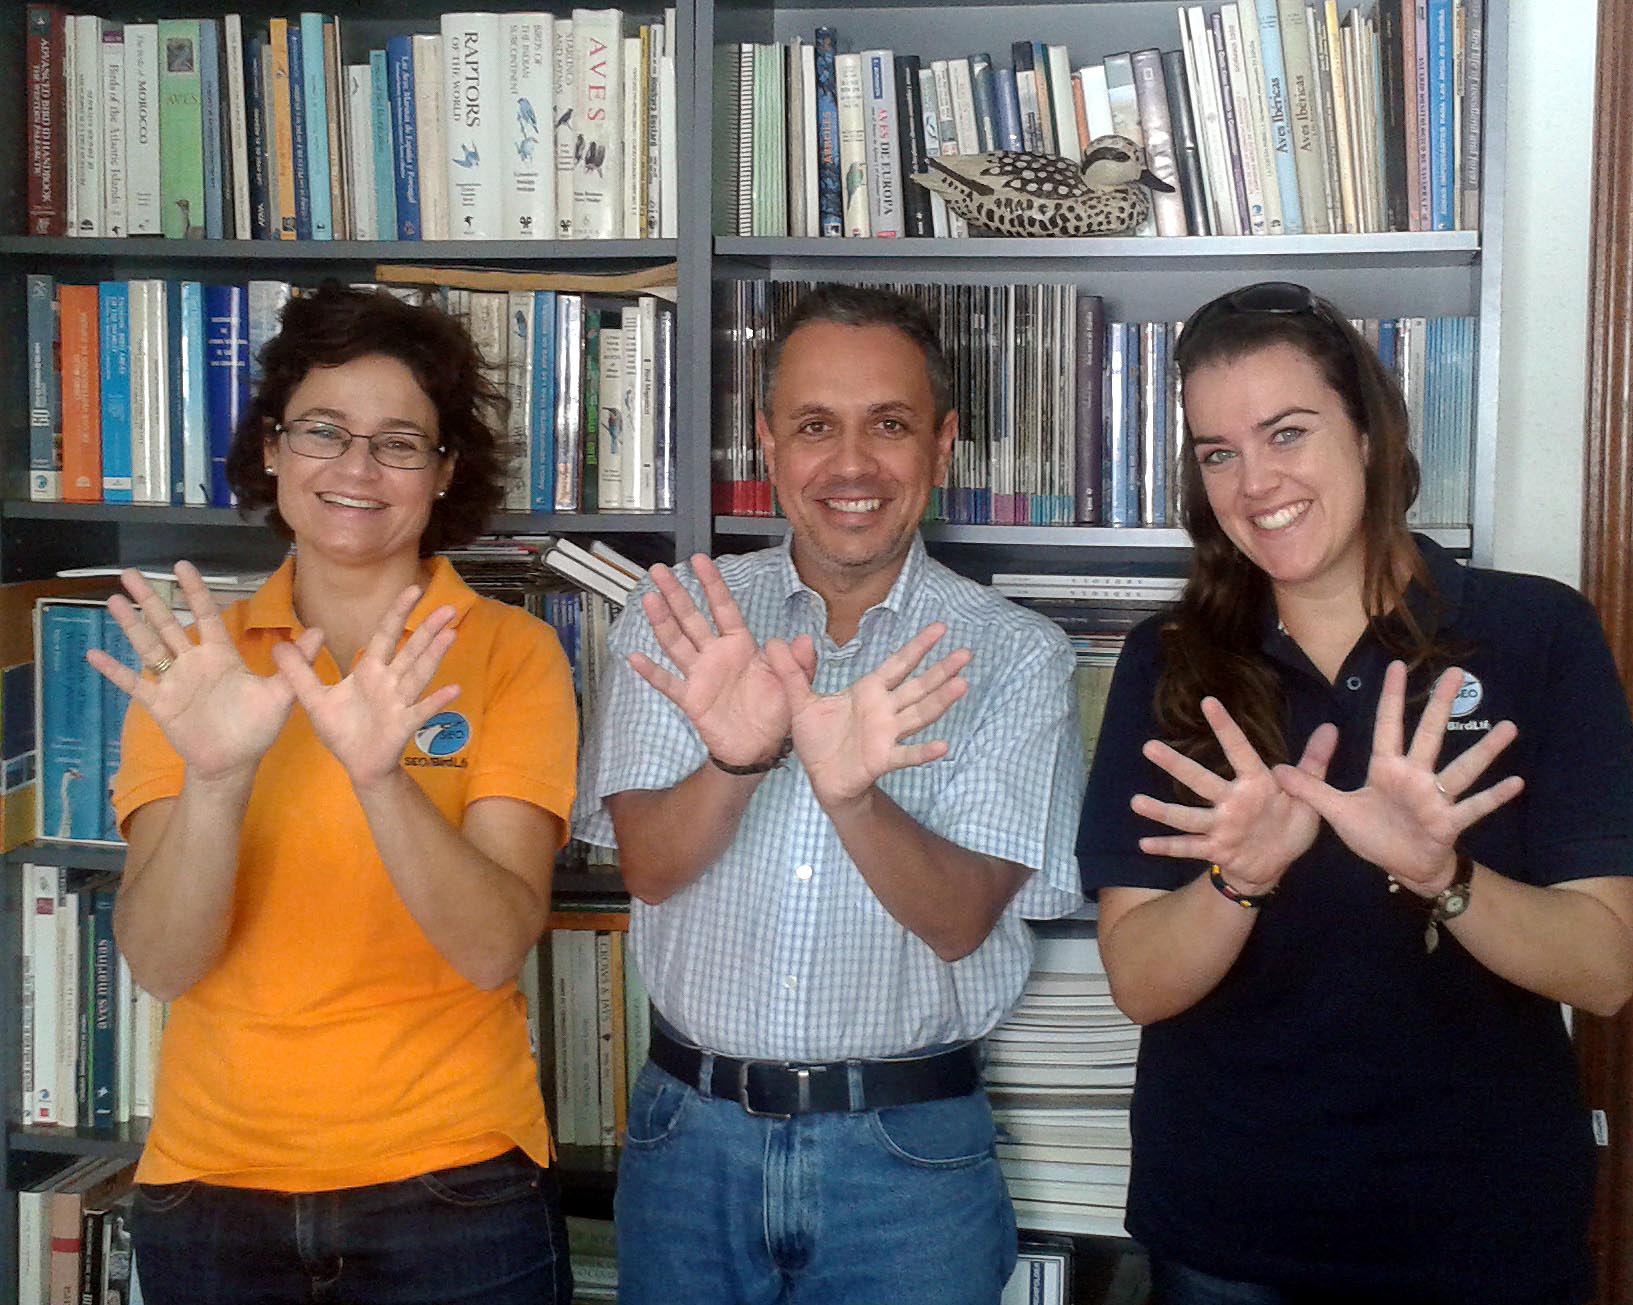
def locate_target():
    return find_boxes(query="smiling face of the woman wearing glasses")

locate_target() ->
[265,354,454,565]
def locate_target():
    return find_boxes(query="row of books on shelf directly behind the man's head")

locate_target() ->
[712,281,1476,526]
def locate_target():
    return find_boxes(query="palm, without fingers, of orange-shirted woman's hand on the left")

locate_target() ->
[149,642,294,777]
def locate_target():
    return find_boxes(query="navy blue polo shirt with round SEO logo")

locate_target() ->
[1078,539,1633,1305]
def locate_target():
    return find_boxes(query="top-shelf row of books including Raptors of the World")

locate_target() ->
[26,3,678,240]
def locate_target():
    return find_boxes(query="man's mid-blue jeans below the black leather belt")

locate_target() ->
[614,1062,1016,1305]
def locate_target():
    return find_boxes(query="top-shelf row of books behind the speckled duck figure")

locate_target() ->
[714,0,1483,237]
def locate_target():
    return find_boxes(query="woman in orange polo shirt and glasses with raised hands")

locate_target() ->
[91,284,576,1305]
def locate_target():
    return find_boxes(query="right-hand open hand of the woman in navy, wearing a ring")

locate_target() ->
[1275,661,1525,897]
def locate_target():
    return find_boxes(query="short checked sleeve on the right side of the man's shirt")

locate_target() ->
[924,630,1083,920]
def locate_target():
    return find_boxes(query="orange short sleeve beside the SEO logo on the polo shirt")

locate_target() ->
[465,609,578,825]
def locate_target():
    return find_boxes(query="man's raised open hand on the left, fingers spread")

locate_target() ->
[629,554,817,766]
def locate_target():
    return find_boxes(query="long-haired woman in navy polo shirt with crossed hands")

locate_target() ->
[1078,283,1633,1305]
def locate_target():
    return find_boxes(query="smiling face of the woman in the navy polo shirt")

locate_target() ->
[1186,336,1367,598]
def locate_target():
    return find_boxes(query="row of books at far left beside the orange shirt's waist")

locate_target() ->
[20,866,165,1129]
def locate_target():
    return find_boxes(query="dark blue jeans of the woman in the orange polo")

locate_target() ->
[131,1150,573,1305]
